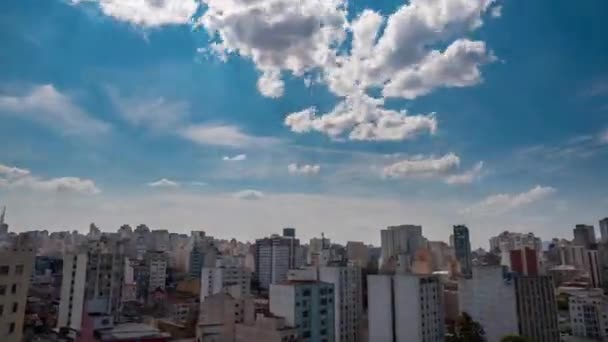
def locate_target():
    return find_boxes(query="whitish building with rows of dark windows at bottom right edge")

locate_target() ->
[568,291,608,341]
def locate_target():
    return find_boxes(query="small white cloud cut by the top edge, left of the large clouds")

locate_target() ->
[72,0,199,27]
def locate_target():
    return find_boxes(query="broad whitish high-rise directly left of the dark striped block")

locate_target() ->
[458,266,519,341]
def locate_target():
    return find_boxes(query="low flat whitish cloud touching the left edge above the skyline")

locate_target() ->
[0,164,101,195]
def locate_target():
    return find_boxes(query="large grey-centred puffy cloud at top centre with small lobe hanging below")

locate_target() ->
[198,0,347,97]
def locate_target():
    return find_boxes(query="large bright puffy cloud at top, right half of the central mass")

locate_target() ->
[324,0,495,99]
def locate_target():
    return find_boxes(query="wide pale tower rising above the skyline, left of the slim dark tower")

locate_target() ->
[380,225,424,263]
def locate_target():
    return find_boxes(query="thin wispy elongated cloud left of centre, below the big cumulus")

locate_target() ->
[179,124,279,147]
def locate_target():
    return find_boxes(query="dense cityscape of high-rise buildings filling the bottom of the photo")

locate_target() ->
[0,207,608,342]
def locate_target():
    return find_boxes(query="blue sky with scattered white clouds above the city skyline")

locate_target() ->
[0,0,608,248]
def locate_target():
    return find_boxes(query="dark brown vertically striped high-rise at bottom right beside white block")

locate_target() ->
[514,275,560,342]
